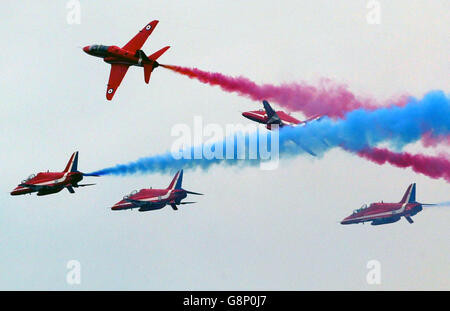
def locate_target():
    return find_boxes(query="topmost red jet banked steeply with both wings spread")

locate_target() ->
[83,20,170,100]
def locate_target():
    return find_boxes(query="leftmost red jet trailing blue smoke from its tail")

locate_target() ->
[11,151,96,195]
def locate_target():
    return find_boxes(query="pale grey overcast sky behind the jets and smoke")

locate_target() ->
[0,0,450,290]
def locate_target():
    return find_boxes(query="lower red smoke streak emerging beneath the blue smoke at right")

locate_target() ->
[358,148,450,182]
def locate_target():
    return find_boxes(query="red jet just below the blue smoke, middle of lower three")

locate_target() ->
[111,170,202,212]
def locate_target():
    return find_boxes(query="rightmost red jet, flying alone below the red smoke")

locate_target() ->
[341,183,436,226]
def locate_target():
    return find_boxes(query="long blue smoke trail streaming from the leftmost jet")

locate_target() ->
[91,91,450,175]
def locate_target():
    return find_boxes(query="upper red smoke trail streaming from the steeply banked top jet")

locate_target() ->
[161,65,407,118]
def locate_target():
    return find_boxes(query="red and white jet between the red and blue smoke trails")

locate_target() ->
[242,100,322,130]
